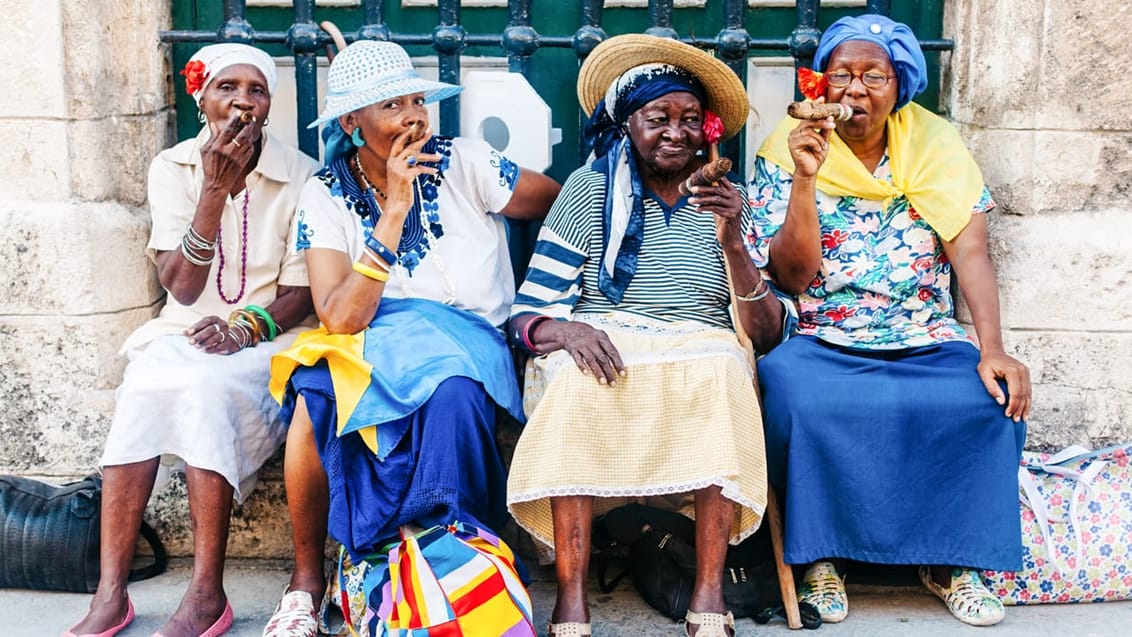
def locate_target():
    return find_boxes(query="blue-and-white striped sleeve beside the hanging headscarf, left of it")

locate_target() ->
[511,167,604,319]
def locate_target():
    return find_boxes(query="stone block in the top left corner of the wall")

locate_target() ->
[0,0,67,118]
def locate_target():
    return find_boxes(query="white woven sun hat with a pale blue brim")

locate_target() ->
[307,40,463,128]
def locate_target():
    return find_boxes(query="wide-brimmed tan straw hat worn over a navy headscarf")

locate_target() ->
[577,34,751,139]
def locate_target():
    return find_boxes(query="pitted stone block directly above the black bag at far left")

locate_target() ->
[0,307,155,476]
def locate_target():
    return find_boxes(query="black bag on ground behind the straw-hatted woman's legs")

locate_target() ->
[593,503,782,619]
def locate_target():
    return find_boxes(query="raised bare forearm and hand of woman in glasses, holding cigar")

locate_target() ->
[766,118,835,295]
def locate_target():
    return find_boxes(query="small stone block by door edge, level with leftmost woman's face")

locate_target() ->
[68,111,174,206]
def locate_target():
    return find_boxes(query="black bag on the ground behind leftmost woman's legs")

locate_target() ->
[0,474,169,593]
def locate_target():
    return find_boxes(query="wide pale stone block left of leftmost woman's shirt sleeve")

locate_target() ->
[0,201,163,314]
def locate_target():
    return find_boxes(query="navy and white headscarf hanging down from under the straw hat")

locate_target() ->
[582,63,708,304]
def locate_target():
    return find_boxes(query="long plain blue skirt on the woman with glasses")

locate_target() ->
[758,336,1026,570]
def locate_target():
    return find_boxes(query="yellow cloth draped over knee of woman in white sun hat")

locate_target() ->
[268,326,377,454]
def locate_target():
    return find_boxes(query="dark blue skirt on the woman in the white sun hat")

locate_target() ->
[291,362,507,562]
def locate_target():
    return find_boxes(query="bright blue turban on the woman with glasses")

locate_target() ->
[814,14,927,111]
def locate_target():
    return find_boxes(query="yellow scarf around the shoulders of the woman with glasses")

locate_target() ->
[758,102,984,241]
